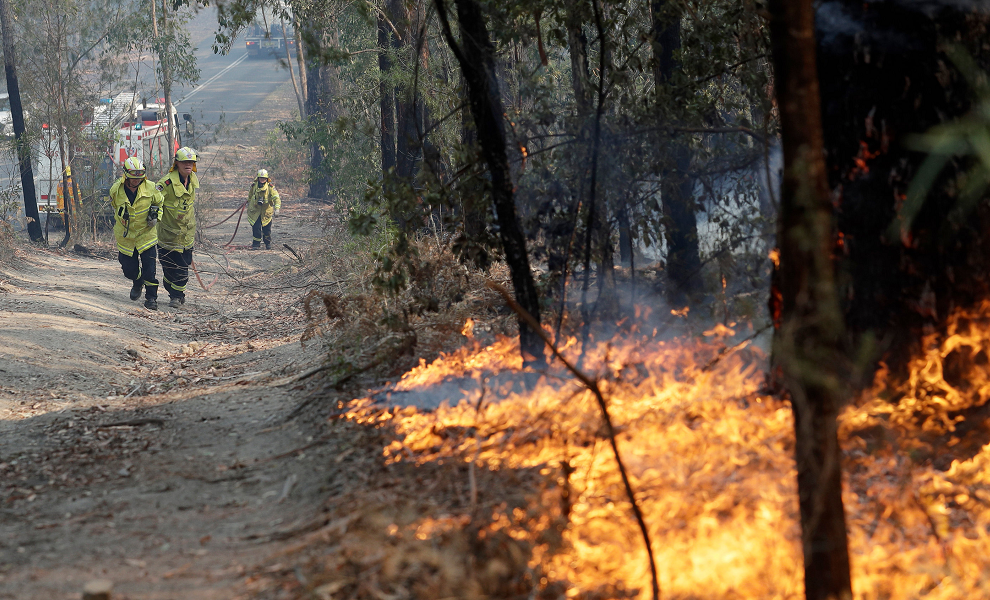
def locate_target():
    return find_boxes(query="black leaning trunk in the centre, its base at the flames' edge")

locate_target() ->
[434,0,545,366]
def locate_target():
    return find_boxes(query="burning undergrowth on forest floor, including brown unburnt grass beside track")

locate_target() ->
[254,302,990,599]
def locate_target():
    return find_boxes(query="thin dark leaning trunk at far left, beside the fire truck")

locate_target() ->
[0,0,45,242]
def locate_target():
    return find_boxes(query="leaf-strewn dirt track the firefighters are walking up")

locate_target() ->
[0,82,364,600]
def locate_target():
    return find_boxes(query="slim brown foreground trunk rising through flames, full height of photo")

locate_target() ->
[769,0,852,600]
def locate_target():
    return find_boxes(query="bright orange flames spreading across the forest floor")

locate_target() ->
[350,302,990,600]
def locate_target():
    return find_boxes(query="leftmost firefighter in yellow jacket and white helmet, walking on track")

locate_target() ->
[110,156,162,310]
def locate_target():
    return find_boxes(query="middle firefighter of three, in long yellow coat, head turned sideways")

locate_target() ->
[155,147,199,308]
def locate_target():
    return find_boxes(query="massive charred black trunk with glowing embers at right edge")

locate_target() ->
[817,0,990,380]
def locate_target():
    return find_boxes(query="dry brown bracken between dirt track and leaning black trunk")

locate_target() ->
[303,223,515,378]
